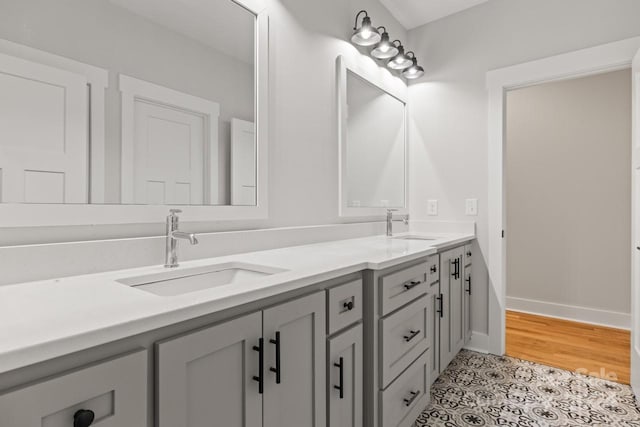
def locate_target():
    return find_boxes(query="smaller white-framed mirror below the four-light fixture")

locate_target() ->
[338,57,407,216]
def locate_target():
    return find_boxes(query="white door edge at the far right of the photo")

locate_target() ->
[631,46,640,396]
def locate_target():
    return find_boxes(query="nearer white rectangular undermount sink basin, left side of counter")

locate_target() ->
[117,263,286,296]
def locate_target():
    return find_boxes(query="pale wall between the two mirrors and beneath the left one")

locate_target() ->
[0,0,407,245]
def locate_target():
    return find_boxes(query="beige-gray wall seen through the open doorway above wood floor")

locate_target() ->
[506,70,631,321]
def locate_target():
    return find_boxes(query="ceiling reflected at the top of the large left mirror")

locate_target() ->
[108,0,255,64]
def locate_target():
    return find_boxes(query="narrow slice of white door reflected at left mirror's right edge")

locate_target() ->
[231,119,256,206]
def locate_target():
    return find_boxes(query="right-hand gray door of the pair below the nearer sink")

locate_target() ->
[263,291,327,427]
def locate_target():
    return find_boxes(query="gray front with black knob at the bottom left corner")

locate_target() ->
[0,350,147,427]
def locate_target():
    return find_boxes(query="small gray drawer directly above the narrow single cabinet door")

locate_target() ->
[327,279,362,335]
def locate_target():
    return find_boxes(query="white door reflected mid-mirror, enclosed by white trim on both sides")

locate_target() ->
[134,100,205,205]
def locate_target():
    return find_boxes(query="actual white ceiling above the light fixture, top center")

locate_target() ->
[380,0,488,30]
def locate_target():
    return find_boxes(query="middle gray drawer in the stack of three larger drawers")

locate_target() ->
[379,295,433,388]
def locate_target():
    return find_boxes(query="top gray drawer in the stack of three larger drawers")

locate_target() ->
[380,262,429,316]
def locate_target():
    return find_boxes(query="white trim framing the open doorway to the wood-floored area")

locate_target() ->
[487,37,640,355]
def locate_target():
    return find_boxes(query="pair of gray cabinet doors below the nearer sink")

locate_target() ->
[156,292,326,427]
